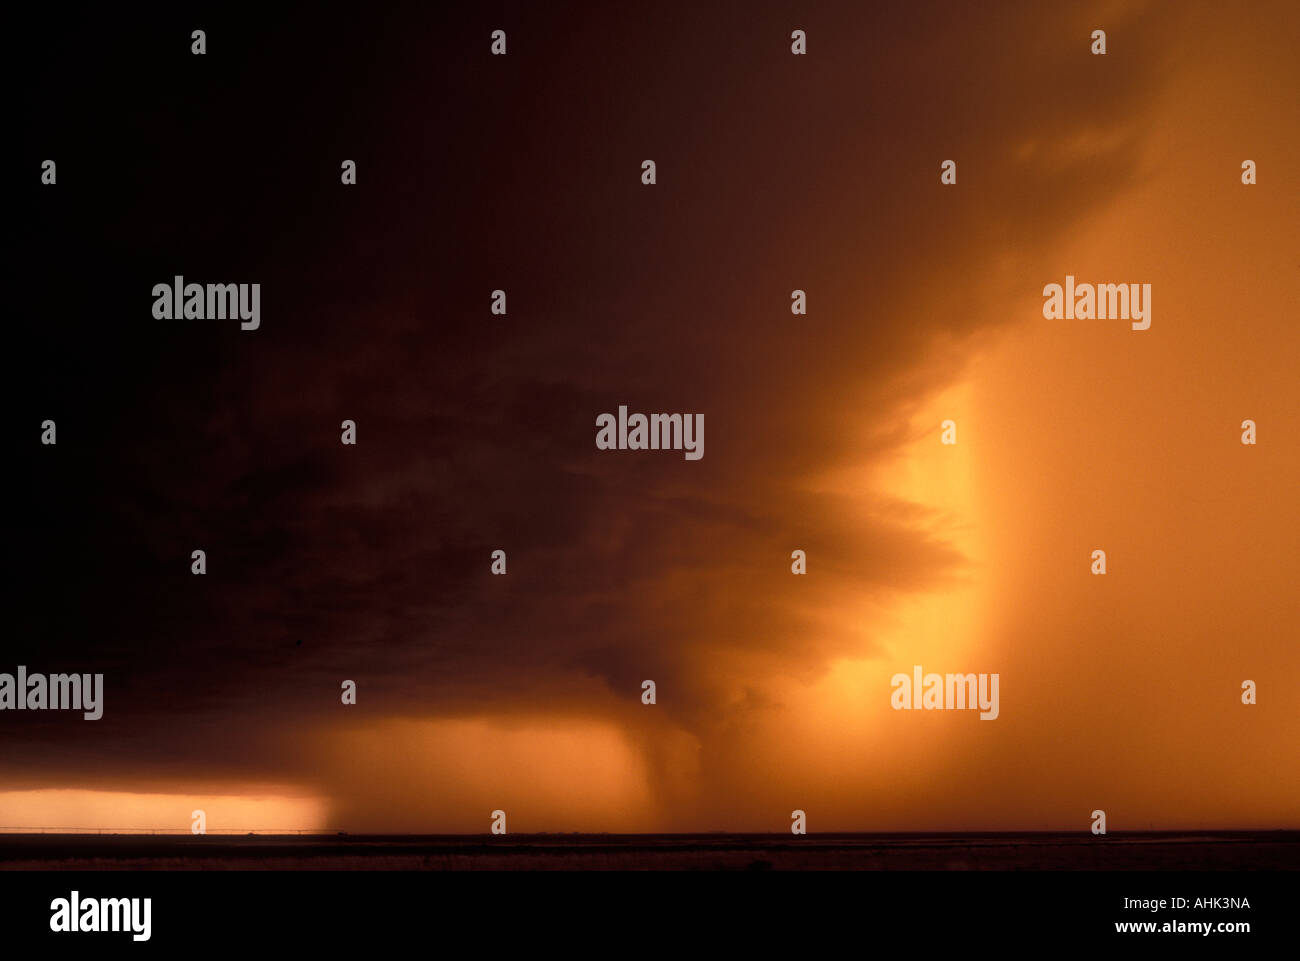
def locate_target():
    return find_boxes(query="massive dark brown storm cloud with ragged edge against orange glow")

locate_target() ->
[0,4,1173,782]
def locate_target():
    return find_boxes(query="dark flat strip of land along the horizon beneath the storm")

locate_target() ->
[0,831,1300,871]
